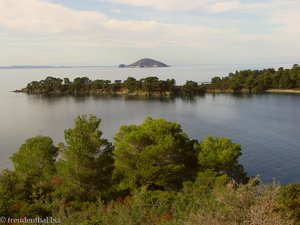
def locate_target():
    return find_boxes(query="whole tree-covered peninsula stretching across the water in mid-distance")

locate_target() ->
[16,64,300,97]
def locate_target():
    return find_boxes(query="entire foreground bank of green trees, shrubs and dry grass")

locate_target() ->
[0,116,300,225]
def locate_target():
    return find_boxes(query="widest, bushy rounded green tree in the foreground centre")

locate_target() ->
[114,118,197,190]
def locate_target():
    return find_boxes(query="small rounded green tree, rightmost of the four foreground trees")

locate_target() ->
[195,136,247,182]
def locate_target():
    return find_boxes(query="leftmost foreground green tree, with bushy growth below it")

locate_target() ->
[0,136,57,217]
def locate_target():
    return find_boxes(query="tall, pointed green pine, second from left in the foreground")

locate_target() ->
[57,115,113,200]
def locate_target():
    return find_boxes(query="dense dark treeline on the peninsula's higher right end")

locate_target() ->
[207,64,300,93]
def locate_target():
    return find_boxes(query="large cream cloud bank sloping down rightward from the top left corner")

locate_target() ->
[0,0,244,48]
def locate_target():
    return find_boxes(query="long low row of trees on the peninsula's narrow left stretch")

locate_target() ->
[20,77,204,96]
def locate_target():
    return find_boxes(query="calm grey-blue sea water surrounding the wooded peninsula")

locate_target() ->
[0,65,300,184]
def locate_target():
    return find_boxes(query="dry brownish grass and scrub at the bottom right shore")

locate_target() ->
[184,182,293,225]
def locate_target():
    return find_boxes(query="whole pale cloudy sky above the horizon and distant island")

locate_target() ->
[0,0,300,66]
